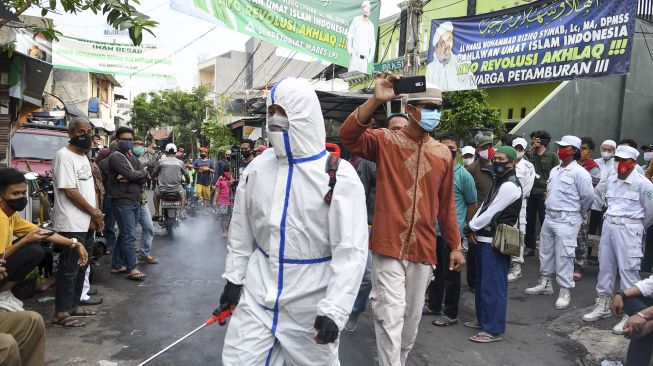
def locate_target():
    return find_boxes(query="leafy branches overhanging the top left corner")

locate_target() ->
[0,0,158,45]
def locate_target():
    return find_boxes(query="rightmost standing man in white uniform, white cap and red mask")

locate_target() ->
[583,146,653,334]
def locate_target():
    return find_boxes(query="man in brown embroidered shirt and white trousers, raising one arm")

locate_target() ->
[340,72,465,366]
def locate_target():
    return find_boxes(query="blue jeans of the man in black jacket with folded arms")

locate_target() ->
[111,205,140,271]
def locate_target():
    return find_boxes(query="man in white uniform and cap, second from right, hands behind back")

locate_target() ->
[524,136,594,310]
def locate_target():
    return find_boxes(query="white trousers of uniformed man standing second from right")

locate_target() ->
[540,210,583,288]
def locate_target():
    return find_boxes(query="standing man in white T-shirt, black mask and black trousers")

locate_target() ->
[52,117,104,328]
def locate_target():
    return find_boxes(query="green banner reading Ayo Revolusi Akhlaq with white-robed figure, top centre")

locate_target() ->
[170,0,381,74]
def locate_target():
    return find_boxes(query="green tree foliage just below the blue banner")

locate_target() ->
[438,89,506,141]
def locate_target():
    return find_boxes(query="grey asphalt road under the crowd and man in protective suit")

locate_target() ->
[26,212,627,366]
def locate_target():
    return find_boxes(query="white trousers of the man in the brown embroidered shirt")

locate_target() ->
[370,253,432,366]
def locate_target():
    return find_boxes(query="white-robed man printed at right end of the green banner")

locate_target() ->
[347,0,376,74]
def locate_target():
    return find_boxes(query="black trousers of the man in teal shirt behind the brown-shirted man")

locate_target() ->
[427,236,460,319]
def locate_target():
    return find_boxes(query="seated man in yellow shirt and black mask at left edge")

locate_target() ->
[0,168,88,314]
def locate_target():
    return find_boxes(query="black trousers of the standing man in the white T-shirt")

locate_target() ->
[54,232,93,313]
